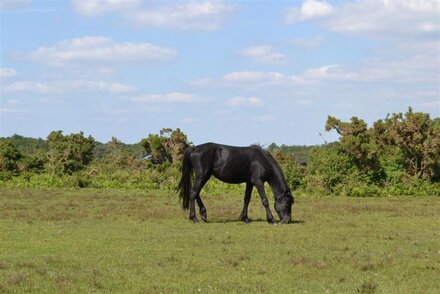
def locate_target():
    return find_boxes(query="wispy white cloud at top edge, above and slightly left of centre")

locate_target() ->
[125,1,235,31]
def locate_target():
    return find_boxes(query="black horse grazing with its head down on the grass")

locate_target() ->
[178,143,294,224]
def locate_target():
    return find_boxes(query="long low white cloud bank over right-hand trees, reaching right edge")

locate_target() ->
[197,54,439,92]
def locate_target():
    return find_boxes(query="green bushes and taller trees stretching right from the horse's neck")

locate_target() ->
[275,108,440,196]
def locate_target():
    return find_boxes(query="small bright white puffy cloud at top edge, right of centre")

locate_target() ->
[285,0,334,24]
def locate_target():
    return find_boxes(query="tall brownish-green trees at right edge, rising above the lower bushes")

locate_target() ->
[326,107,440,182]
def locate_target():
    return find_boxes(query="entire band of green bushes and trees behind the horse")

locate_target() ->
[0,108,440,196]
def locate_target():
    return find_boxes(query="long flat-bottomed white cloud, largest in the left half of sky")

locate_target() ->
[24,37,176,66]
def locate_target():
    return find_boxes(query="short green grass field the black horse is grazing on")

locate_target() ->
[0,189,440,293]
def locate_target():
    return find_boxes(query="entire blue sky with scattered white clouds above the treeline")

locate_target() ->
[0,0,440,145]
